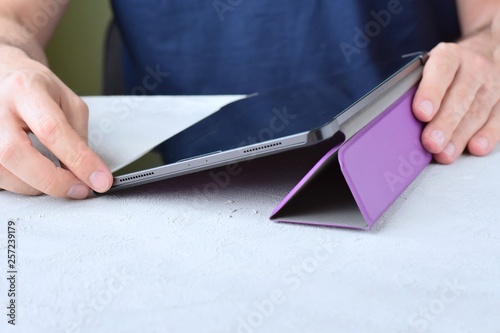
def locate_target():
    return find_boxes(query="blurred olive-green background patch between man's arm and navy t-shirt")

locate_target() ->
[47,0,112,96]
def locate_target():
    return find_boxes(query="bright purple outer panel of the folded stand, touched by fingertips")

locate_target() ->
[339,88,432,227]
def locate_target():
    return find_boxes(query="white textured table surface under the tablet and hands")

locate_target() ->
[0,97,500,333]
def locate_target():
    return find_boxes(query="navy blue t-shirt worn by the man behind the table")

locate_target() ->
[112,0,460,95]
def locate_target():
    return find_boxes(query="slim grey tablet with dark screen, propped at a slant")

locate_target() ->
[110,52,427,191]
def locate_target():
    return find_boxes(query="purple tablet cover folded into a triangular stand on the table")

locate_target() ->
[271,87,432,229]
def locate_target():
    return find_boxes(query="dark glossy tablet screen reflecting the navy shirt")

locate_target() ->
[117,53,424,175]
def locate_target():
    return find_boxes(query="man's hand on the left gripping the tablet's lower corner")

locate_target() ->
[0,45,112,199]
